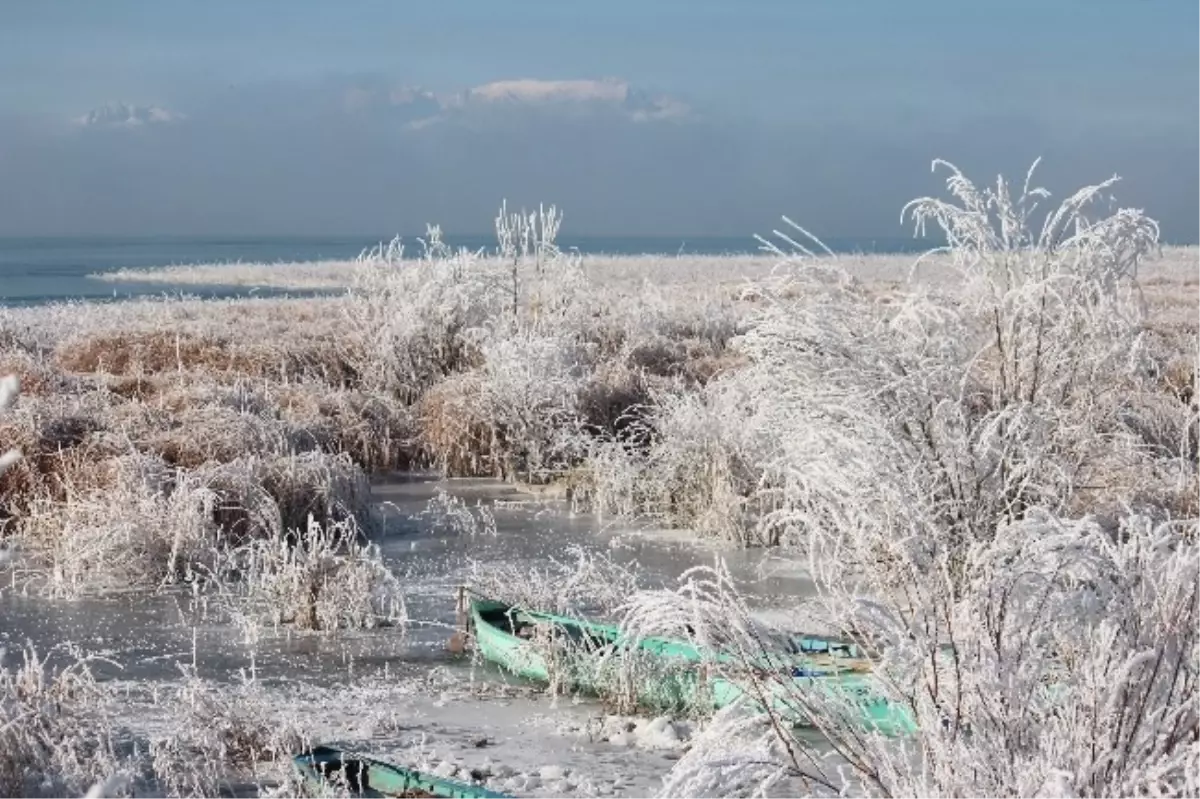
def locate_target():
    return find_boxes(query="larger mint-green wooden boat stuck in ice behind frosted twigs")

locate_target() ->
[469,596,916,734]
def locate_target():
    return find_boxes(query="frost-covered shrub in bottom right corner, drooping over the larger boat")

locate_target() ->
[648,511,1200,798]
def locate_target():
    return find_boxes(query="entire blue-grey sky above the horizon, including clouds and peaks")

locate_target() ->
[0,0,1200,241]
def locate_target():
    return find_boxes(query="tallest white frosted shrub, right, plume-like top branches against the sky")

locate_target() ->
[737,160,1157,556]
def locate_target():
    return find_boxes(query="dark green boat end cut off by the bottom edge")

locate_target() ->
[292,746,515,799]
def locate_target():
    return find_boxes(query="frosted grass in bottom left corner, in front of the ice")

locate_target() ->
[0,648,312,799]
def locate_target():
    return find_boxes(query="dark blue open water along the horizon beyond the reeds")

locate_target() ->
[0,235,931,307]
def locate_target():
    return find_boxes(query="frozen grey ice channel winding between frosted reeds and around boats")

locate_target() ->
[0,475,811,795]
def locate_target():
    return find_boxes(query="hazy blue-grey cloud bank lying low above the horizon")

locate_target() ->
[0,76,1200,242]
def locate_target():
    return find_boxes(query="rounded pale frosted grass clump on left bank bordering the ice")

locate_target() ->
[17,453,368,596]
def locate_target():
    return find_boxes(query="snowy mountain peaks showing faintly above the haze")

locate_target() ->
[73,78,692,128]
